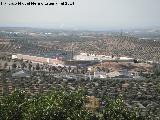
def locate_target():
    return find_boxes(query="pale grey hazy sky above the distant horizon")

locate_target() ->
[0,0,160,29]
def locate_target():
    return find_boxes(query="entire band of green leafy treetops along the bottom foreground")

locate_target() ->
[0,88,149,120]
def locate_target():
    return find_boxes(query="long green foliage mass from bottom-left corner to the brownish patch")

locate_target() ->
[0,89,90,120]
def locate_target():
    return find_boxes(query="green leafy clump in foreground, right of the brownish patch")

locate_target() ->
[103,97,143,120]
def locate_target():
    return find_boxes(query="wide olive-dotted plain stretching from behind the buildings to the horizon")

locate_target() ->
[0,28,160,61]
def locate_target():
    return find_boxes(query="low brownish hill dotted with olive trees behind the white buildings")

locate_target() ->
[73,36,160,61]
